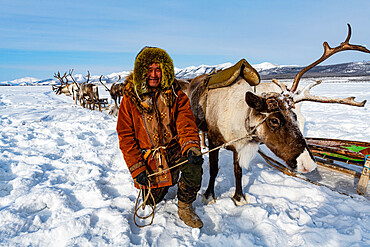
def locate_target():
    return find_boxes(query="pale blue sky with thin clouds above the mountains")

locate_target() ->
[0,0,370,81]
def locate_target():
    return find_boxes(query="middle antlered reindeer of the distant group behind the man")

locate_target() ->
[69,70,101,111]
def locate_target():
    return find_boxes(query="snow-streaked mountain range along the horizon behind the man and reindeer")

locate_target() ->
[0,61,370,86]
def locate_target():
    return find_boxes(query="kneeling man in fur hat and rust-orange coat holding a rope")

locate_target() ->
[117,47,203,228]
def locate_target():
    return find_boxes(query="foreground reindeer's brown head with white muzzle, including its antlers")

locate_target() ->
[245,24,370,172]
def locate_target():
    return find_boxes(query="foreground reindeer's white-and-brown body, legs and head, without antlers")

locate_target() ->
[189,77,316,205]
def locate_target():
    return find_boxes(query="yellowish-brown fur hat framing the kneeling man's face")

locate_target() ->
[133,46,175,97]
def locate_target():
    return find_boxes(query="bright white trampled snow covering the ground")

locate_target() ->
[0,80,370,247]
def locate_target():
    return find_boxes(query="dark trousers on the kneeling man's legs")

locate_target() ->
[142,158,203,205]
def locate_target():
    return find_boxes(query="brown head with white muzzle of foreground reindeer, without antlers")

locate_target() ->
[245,92,316,172]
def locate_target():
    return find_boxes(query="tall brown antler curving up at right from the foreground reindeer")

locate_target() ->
[290,23,370,92]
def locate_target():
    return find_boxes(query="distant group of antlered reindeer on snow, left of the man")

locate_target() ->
[52,69,125,113]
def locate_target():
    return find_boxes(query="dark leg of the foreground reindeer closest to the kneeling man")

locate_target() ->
[203,138,219,204]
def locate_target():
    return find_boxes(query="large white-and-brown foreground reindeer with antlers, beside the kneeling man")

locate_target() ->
[188,24,370,205]
